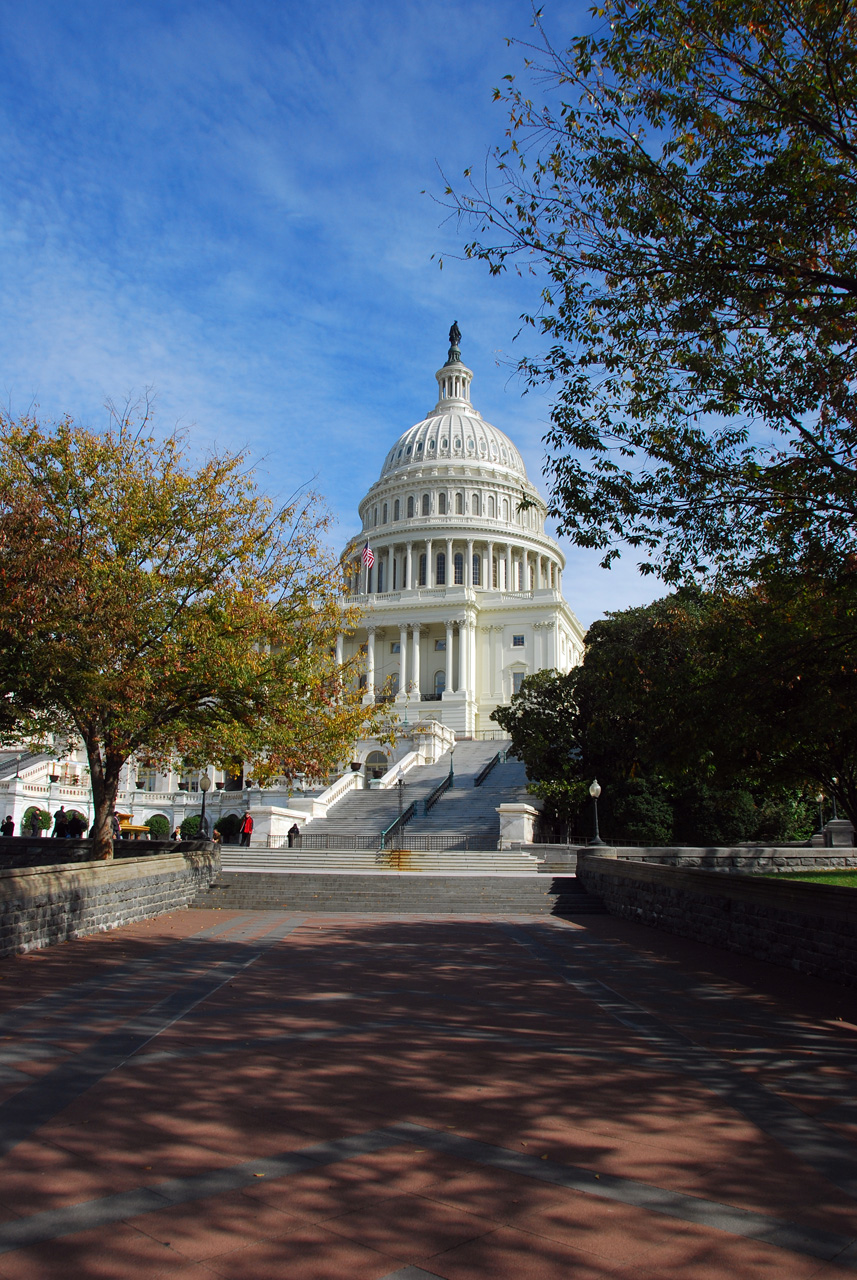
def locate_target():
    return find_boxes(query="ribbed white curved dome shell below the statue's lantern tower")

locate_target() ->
[381,401,527,480]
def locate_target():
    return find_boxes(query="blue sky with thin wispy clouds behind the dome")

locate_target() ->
[0,0,661,625]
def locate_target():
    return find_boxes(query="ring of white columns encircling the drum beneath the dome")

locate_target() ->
[350,538,559,595]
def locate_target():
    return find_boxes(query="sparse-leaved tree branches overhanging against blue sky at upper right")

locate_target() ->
[448,0,857,581]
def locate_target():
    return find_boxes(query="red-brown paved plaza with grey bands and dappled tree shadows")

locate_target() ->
[0,910,857,1280]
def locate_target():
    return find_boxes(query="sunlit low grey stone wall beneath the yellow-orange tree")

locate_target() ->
[0,841,220,956]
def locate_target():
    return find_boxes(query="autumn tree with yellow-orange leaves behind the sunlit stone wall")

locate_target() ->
[0,413,372,858]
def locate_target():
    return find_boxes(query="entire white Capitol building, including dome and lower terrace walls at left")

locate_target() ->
[0,325,583,844]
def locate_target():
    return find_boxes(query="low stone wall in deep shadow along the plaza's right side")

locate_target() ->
[577,854,857,986]
